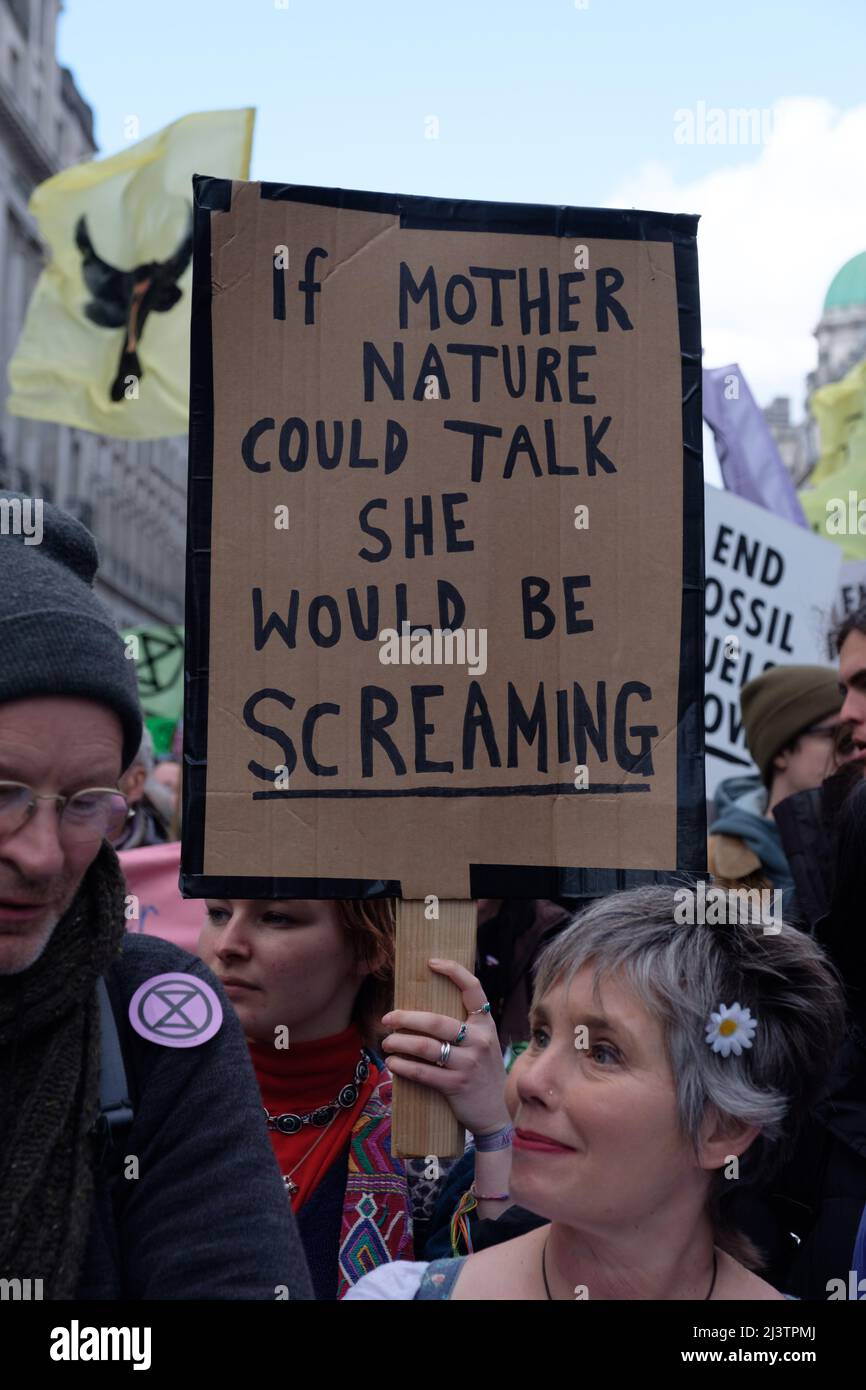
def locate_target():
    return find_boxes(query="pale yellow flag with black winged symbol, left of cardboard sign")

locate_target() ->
[7,108,256,439]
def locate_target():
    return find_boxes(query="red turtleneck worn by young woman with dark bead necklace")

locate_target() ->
[249,1026,379,1212]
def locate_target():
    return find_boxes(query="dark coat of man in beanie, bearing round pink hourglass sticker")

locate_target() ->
[76,933,311,1301]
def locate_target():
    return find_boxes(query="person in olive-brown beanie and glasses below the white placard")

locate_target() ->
[708,666,855,912]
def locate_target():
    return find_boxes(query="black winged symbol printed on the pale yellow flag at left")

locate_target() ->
[75,213,192,400]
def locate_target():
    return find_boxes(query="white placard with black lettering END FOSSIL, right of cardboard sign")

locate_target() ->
[705,487,841,796]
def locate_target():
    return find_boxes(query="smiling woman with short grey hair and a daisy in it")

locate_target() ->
[343,887,844,1300]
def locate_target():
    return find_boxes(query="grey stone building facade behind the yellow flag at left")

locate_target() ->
[0,0,186,627]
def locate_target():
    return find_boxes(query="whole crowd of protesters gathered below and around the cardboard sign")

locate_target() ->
[0,489,866,1301]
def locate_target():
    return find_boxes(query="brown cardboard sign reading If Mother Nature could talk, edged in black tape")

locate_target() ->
[182,178,706,899]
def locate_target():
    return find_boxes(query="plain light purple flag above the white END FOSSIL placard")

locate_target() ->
[703,363,809,528]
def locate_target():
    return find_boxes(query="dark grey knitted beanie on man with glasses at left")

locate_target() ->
[0,491,142,769]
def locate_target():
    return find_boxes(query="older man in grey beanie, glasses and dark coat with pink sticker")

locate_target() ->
[0,493,310,1300]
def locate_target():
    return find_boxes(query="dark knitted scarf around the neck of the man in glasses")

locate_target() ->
[0,844,126,1298]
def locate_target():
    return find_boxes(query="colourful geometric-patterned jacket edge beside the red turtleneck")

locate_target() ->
[336,1058,414,1298]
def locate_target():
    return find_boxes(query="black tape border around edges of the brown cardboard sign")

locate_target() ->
[181,174,706,899]
